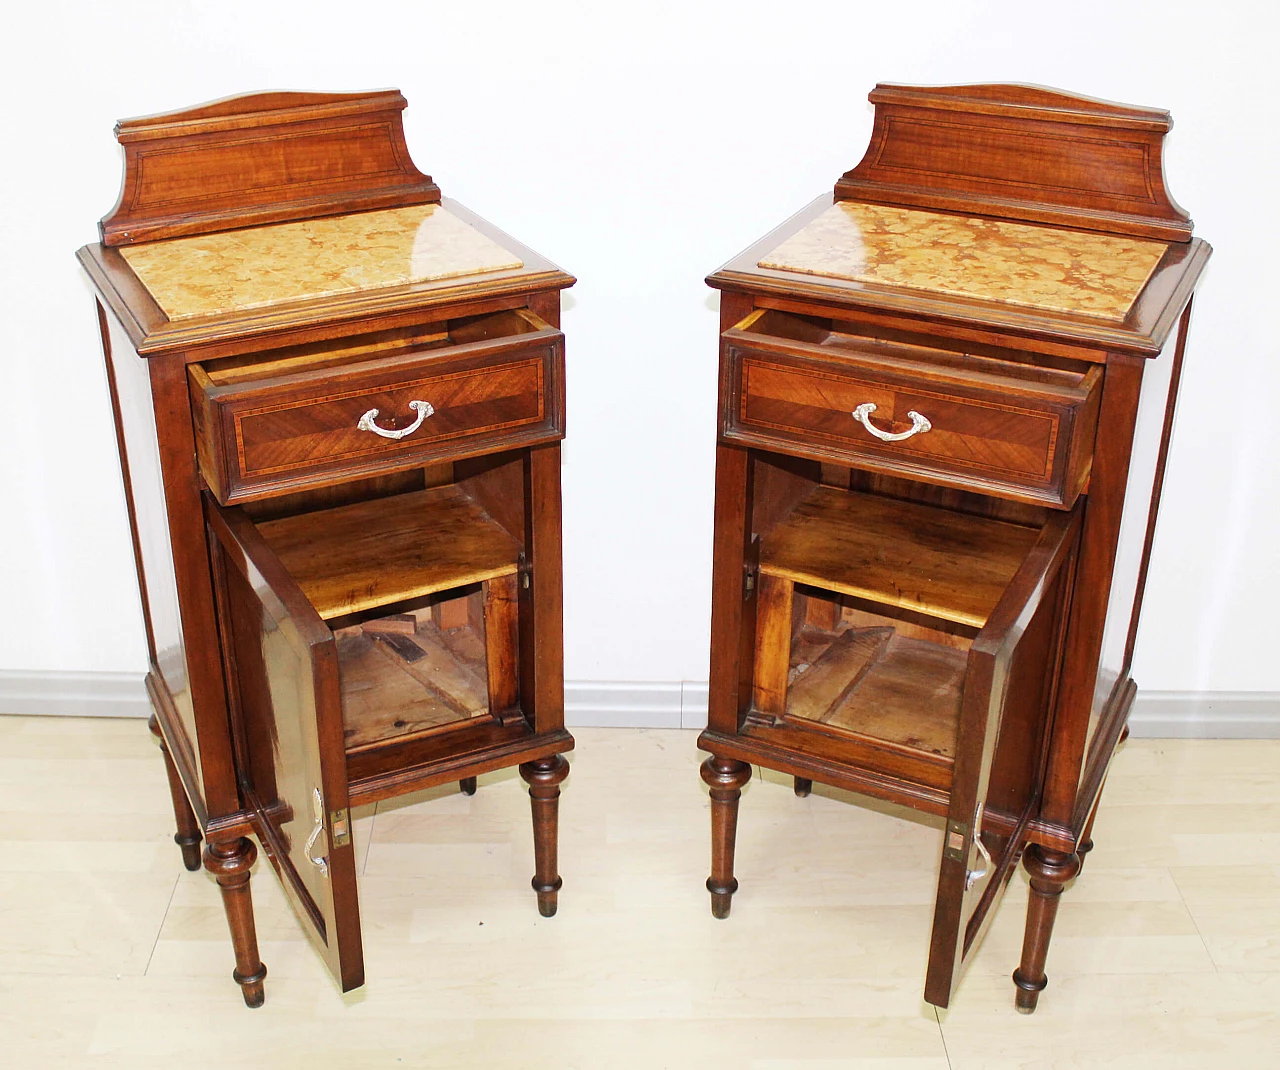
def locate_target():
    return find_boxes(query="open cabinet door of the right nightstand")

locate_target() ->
[924,506,1082,1007]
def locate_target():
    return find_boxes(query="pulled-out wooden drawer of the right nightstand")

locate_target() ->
[721,310,1102,508]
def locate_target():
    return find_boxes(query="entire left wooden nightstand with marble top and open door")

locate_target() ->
[78,91,573,1006]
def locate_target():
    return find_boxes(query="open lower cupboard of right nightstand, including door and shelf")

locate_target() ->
[740,486,1080,1006]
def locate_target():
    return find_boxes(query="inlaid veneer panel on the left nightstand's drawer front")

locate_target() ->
[234,360,545,476]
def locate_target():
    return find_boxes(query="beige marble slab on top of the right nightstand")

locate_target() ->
[759,201,1166,323]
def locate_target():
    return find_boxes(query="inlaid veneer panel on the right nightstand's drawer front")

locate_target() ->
[739,357,1060,483]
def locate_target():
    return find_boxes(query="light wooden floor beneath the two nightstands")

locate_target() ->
[0,717,1280,1070]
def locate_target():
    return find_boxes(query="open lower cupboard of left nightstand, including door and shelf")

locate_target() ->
[205,484,555,991]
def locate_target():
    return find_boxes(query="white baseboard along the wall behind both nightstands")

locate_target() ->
[0,671,1280,740]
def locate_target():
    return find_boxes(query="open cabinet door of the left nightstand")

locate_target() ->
[205,497,365,992]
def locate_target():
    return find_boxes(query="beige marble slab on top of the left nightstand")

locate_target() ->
[120,205,524,320]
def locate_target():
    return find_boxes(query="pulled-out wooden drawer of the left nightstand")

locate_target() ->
[189,308,564,504]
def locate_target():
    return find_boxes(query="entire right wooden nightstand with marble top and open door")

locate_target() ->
[700,86,1210,1012]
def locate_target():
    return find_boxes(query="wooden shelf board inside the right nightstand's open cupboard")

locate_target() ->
[760,486,1039,628]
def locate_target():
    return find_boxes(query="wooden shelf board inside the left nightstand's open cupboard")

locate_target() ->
[257,485,520,621]
